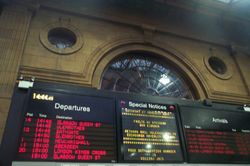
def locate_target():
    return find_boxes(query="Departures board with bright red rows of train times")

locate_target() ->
[16,91,116,162]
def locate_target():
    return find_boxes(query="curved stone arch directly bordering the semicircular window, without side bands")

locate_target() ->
[90,38,208,99]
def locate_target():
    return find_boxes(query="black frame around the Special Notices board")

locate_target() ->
[116,95,186,164]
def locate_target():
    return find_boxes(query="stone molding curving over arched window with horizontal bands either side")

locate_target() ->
[20,35,250,104]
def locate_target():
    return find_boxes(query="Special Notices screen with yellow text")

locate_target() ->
[118,100,183,163]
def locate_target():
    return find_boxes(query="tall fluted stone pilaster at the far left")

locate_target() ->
[0,5,32,141]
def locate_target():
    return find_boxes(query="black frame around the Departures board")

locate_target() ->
[0,82,118,166]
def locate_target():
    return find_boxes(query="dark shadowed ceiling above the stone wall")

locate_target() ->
[3,0,250,48]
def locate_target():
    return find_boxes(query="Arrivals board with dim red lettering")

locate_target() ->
[181,107,250,163]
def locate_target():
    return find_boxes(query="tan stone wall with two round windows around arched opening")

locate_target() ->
[0,0,250,143]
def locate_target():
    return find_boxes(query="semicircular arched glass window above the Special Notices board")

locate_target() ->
[101,52,195,99]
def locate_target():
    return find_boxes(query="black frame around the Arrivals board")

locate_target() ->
[179,105,250,164]
